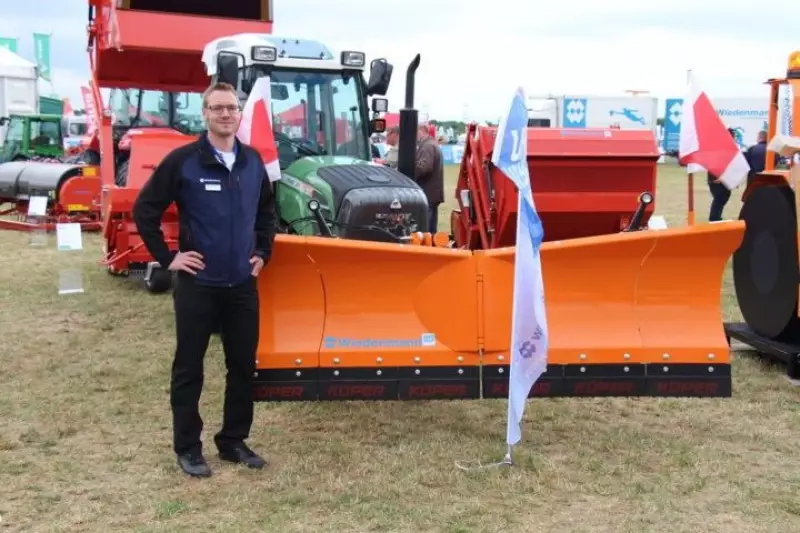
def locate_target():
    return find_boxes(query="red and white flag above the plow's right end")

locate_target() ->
[679,72,750,190]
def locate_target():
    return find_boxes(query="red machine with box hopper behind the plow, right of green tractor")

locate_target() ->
[451,124,660,250]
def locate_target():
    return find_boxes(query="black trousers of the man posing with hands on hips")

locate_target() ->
[170,272,258,454]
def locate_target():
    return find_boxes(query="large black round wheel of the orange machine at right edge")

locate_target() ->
[733,185,800,343]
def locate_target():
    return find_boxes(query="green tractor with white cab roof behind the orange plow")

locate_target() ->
[203,34,428,242]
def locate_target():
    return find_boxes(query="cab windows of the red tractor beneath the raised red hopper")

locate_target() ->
[110,89,205,135]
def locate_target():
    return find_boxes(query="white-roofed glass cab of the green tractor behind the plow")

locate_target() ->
[203,34,392,170]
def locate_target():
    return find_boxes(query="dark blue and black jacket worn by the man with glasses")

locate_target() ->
[133,130,277,287]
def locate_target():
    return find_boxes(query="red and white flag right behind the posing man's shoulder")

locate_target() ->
[236,76,281,182]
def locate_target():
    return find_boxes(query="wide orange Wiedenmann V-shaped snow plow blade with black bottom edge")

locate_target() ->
[255,221,744,401]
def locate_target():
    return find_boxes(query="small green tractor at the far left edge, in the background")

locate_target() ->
[0,115,64,163]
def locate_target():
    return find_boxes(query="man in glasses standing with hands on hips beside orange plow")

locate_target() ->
[133,83,276,477]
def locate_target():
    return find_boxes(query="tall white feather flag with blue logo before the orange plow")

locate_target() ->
[492,88,548,446]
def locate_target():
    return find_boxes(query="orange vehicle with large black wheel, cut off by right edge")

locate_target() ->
[725,50,800,379]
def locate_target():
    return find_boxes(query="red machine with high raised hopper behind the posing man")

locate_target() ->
[83,0,272,292]
